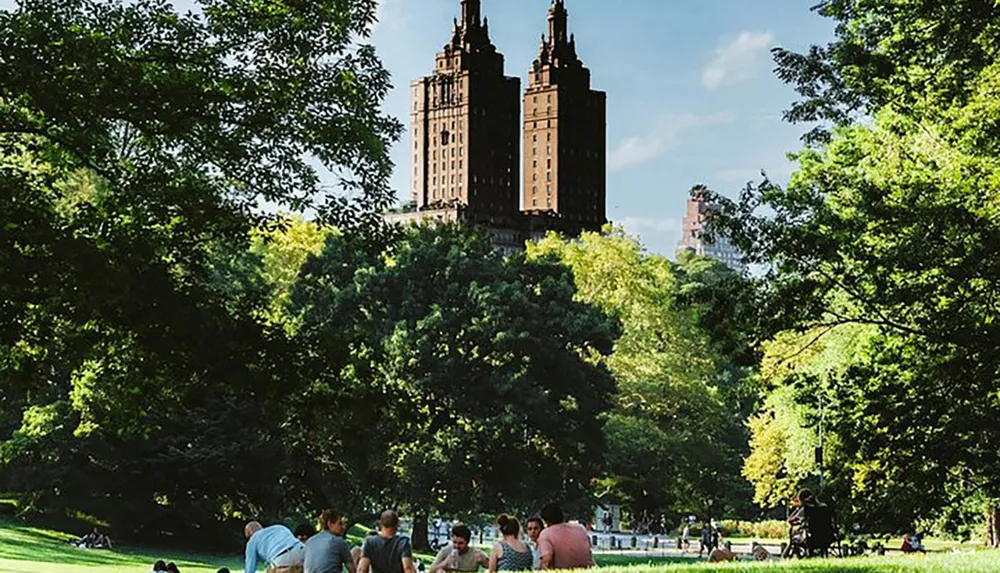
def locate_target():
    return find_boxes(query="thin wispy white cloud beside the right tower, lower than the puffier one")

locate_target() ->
[608,113,735,171]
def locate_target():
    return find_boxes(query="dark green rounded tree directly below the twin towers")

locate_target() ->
[286,222,617,543]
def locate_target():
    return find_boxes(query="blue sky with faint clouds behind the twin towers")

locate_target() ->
[372,0,832,256]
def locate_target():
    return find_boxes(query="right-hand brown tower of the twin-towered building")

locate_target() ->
[524,0,607,230]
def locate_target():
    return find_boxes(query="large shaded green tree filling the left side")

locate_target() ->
[0,0,400,539]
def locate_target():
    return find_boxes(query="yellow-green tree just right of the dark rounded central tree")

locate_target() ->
[528,228,746,526]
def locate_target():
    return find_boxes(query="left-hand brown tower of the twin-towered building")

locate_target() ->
[410,0,521,215]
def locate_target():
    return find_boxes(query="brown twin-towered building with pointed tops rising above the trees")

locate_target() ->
[389,0,607,248]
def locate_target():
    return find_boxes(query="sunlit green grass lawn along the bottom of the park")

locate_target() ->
[0,520,1000,573]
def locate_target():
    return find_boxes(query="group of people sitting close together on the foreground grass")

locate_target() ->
[244,504,594,573]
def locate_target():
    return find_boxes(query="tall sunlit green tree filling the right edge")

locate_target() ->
[714,0,1000,545]
